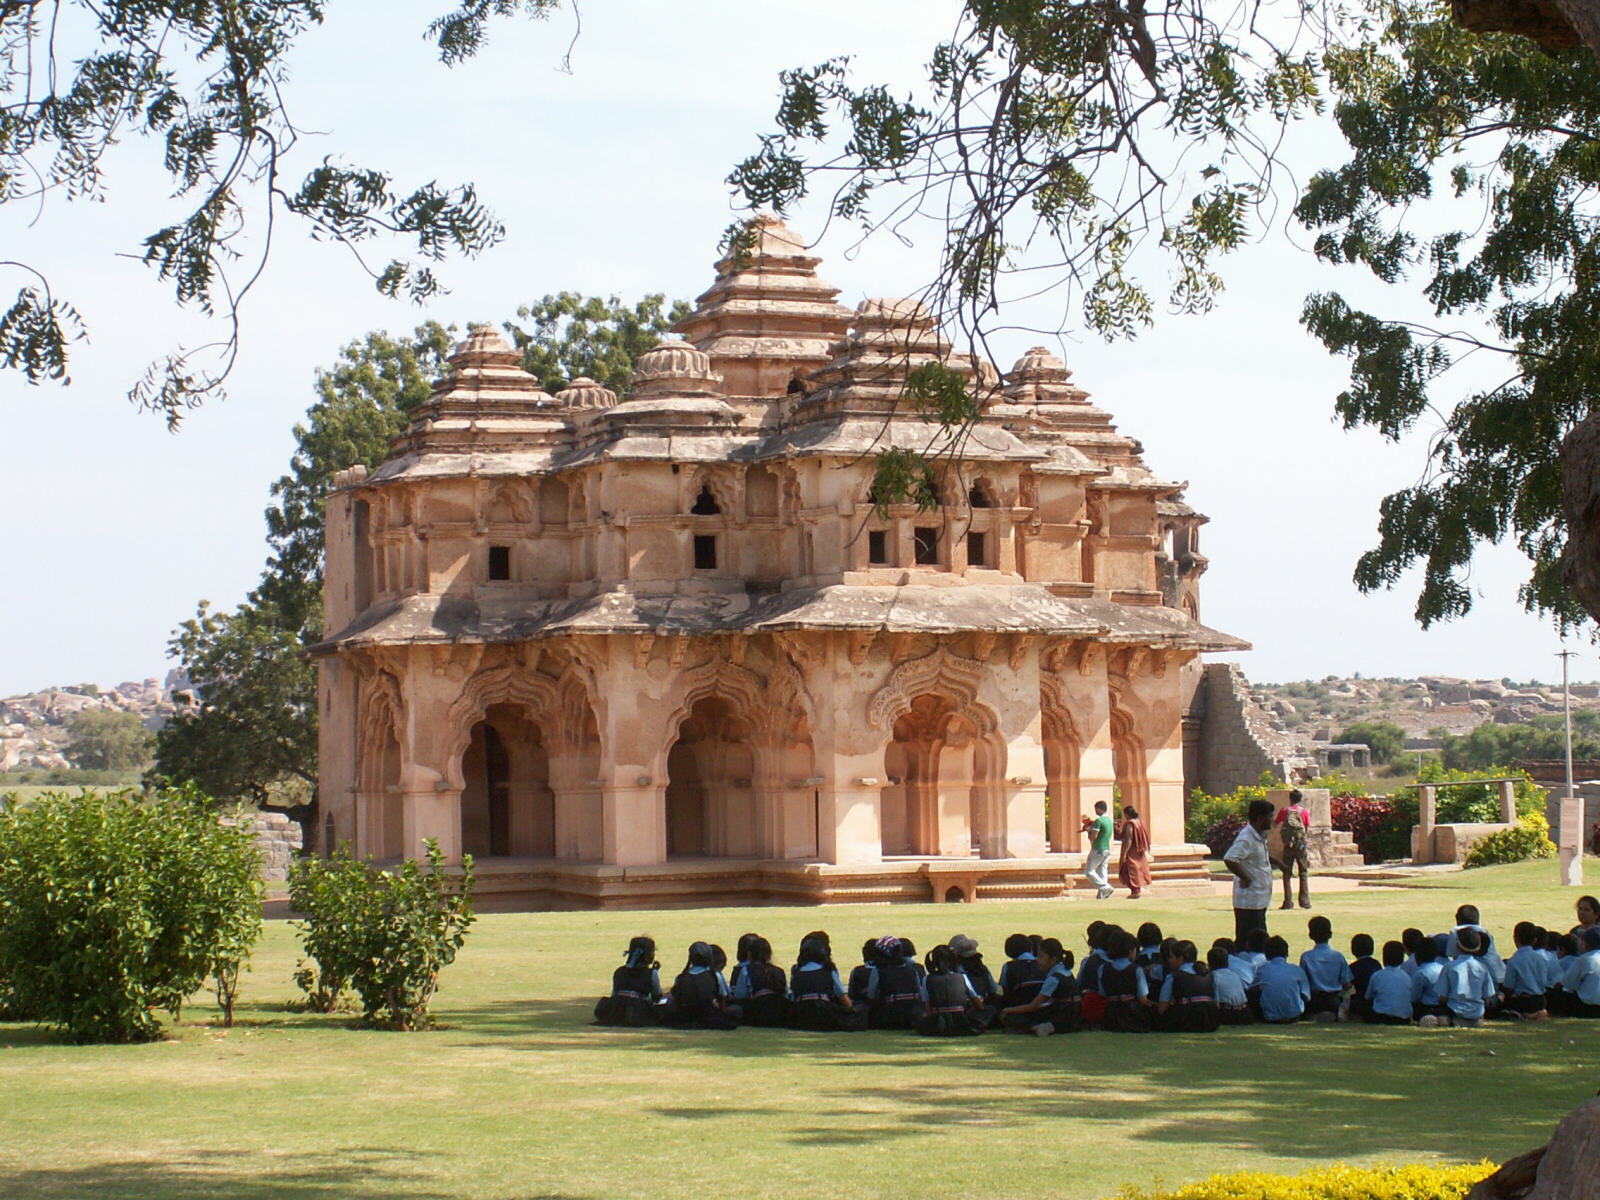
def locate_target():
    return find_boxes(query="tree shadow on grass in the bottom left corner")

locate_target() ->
[0,1147,464,1200]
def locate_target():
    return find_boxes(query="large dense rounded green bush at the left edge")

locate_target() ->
[0,789,261,1042]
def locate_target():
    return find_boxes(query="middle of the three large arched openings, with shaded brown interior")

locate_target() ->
[666,696,755,858]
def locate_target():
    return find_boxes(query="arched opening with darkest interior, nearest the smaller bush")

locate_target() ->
[461,704,555,858]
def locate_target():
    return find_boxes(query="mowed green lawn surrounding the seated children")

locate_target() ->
[0,862,1600,1200]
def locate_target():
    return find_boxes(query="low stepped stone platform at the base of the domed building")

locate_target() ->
[457,845,1211,912]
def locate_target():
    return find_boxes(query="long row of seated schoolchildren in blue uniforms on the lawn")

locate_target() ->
[595,904,1600,1037]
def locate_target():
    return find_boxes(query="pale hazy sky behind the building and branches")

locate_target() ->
[0,0,1600,696]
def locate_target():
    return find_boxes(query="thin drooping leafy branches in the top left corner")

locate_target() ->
[0,0,558,424]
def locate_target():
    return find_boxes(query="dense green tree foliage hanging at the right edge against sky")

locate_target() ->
[1296,0,1600,627]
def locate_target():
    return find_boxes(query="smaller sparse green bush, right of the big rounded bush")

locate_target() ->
[290,840,474,1030]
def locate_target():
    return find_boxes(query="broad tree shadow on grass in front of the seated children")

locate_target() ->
[451,1002,1594,1162]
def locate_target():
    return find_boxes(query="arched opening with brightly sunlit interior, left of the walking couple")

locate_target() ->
[880,693,1003,856]
